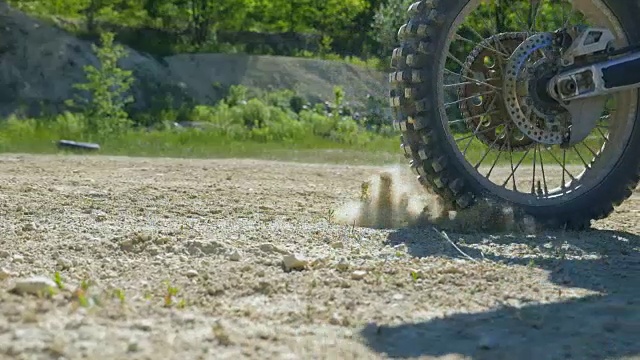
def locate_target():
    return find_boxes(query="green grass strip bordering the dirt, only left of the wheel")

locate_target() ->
[0,121,403,165]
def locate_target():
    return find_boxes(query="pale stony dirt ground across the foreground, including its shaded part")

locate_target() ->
[0,155,640,359]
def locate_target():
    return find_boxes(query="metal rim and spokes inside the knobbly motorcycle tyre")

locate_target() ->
[438,0,638,206]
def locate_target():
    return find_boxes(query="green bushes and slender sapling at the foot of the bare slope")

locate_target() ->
[0,28,392,155]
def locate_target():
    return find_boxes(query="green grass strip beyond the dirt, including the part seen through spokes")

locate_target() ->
[0,118,602,167]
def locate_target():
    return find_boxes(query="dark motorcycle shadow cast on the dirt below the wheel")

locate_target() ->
[362,229,640,360]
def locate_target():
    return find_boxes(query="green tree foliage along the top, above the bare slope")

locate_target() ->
[9,0,584,67]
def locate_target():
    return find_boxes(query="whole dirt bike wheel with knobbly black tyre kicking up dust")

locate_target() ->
[389,0,640,230]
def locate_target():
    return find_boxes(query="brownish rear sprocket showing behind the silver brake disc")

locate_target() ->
[458,32,535,151]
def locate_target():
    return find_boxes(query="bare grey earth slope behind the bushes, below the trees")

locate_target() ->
[0,1,387,116]
